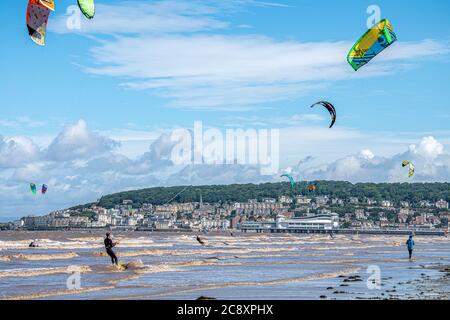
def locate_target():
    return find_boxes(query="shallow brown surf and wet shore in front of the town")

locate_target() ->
[0,231,450,300]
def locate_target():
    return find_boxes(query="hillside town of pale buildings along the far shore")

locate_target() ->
[1,195,450,235]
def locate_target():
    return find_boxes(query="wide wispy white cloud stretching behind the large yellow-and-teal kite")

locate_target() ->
[85,35,448,109]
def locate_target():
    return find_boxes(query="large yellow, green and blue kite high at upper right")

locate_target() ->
[347,19,397,71]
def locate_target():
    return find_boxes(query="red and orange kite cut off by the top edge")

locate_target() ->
[27,0,55,46]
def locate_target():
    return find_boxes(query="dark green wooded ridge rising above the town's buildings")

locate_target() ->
[77,181,450,208]
